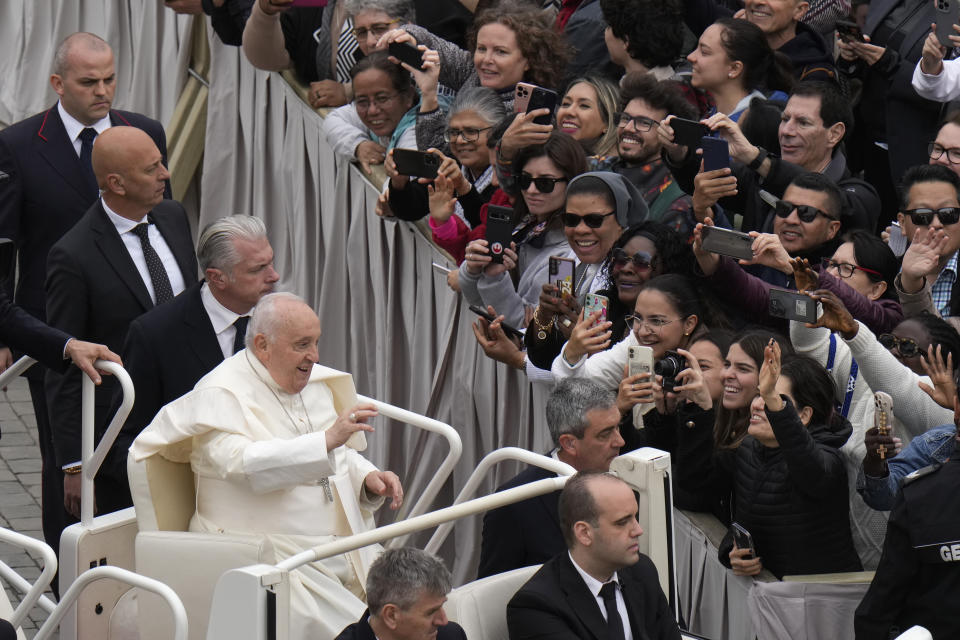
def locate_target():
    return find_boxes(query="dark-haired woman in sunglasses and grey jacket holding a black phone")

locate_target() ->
[458,132,584,327]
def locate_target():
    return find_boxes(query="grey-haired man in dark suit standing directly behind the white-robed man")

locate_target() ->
[101,215,280,486]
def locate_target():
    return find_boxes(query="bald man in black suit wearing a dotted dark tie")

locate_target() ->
[46,127,197,516]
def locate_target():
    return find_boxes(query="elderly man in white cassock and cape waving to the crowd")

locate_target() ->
[130,293,403,638]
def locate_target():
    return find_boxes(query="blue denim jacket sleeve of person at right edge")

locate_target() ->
[857,424,957,511]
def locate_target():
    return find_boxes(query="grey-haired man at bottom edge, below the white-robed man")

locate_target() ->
[336,547,467,640]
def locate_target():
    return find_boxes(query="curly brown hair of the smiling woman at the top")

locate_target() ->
[467,2,573,89]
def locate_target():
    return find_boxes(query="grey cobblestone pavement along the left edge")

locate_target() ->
[0,378,57,638]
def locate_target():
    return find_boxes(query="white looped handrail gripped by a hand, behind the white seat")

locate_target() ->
[80,360,134,527]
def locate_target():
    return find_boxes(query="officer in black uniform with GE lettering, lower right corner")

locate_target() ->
[854,398,960,640]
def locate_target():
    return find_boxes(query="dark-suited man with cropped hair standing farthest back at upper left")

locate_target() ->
[0,32,169,560]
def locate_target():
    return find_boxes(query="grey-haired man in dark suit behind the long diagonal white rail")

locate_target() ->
[477,378,623,578]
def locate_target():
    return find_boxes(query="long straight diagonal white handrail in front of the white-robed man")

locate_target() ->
[276,476,569,571]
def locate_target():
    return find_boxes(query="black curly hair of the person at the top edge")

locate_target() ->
[600,0,683,69]
